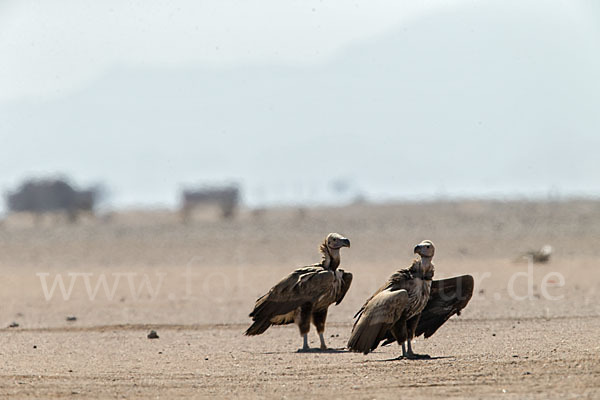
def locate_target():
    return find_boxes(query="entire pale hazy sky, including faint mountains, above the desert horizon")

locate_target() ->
[0,0,600,205]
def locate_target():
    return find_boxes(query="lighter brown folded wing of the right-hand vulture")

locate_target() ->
[348,289,408,354]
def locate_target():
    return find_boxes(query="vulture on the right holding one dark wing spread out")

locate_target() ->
[348,240,474,359]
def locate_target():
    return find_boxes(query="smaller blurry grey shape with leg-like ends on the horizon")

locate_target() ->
[181,185,240,222]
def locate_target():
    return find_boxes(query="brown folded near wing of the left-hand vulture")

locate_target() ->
[246,266,334,336]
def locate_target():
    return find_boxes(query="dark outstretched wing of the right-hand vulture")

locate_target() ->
[415,275,475,338]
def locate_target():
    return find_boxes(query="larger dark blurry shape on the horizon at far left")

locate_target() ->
[6,179,98,222]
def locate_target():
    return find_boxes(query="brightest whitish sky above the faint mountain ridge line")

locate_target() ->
[0,0,450,102]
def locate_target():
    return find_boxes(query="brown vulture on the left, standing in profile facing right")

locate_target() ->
[245,233,352,351]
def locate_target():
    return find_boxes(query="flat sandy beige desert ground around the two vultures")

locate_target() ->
[0,201,600,399]
